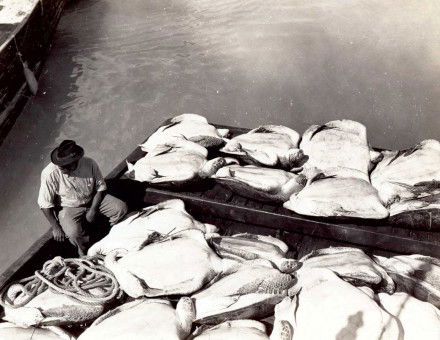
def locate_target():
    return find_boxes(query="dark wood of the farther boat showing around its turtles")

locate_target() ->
[109,125,440,257]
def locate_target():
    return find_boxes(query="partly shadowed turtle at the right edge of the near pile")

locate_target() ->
[373,254,440,308]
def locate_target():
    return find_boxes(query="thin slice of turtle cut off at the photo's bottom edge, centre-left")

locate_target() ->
[189,319,292,340]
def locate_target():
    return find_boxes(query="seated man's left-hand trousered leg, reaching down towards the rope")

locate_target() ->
[58,207,89,256]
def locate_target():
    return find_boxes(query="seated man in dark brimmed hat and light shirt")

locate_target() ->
[38,140,127,256]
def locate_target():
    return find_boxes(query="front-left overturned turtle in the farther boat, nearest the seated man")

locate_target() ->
[126,137,237,186]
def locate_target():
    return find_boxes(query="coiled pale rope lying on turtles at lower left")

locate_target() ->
[0,256,120,308]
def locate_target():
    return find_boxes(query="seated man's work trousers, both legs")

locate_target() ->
[58,194,127,256]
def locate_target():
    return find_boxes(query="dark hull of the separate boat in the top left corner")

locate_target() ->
[0,0,68,143]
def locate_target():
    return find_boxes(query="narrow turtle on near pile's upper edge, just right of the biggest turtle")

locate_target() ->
[209,234,299,273]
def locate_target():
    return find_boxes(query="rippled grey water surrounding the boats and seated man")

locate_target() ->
[0,0,440,268]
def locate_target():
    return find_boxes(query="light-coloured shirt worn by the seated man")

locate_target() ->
[38,157,107,208]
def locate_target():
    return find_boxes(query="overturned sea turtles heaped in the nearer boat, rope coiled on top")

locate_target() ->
[0,199,440,340]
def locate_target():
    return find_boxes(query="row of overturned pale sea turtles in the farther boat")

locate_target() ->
[126,113,440,230]
